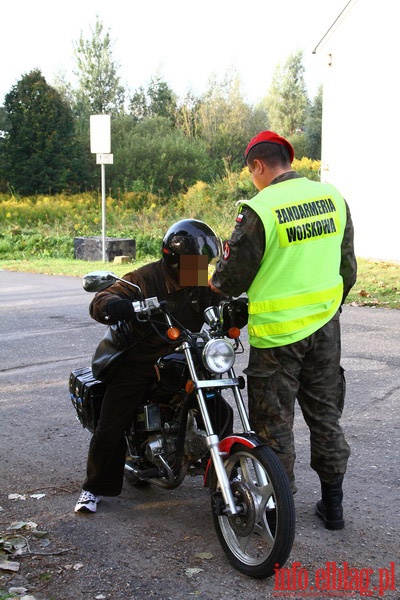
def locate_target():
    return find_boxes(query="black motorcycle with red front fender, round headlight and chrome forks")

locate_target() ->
[70,271,295,579]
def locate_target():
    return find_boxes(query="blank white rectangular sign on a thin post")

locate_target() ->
[90,115,114,262]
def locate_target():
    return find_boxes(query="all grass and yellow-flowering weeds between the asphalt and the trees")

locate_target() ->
[0,159,400,308]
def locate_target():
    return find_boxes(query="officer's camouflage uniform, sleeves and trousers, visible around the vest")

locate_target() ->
[211,171,357,490]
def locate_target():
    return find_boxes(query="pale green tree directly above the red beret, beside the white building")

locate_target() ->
[265,51,308,137]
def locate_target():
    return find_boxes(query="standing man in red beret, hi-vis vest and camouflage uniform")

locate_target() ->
[210,131,357,529]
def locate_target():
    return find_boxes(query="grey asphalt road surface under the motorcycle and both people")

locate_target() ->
[0,271,400,600]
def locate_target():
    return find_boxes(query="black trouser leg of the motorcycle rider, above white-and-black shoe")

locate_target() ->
[82,352,155,496]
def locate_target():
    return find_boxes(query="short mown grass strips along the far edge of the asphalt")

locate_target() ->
[0,257,400,309]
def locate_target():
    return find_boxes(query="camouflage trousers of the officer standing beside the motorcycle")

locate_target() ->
[245,315,350,490]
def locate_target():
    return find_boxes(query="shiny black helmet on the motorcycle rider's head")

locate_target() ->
[162,219,222,266]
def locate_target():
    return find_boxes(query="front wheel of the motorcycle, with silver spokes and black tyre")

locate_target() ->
[211,444,295,579]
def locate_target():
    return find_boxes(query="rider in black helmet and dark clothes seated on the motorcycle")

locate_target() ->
[75,219,222,513]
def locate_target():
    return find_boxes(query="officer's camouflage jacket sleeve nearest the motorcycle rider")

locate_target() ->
[211,206,265,297]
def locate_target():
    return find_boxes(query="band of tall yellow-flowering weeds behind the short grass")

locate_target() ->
[0,158,320,258]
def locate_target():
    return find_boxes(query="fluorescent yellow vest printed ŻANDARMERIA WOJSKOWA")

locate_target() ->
[242,177,346,348]
